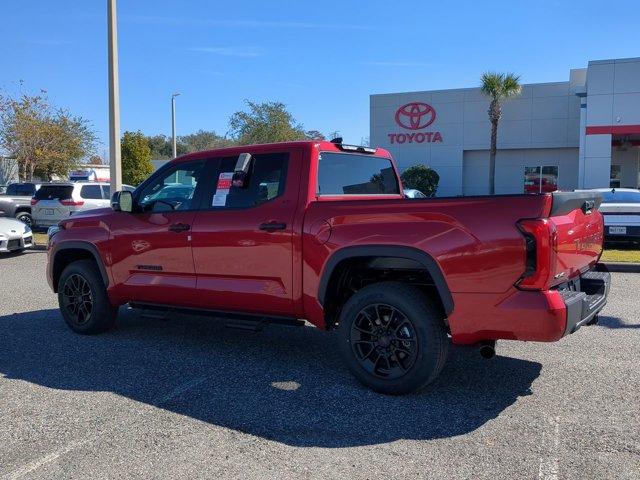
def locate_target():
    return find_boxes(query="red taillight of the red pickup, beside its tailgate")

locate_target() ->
[516,218,556,290]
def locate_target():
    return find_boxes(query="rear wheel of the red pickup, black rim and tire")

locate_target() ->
[338,282,449,395]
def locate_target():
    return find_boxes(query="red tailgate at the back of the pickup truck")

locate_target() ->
[549,192,604,285]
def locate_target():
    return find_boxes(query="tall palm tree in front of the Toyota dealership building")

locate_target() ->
[480,72,522,195]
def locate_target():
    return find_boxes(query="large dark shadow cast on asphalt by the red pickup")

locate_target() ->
[0,309,541,448]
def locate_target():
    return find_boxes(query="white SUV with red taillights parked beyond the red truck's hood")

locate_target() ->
[31,182,134,228]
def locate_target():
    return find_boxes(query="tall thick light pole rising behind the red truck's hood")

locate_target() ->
[107,0,122,193]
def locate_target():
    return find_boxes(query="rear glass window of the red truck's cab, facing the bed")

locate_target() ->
[316,152,400,196]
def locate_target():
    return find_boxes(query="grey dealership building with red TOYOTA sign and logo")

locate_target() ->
[370,58,640,196]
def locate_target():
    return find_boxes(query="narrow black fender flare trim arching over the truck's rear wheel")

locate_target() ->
[318,245,453,316]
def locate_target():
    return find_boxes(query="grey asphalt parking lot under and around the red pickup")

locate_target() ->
[0,252,640,479]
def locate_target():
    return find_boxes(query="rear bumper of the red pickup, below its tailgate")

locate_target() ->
[559,271,611,335]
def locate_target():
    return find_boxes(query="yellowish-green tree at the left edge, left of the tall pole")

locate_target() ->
[0,91,96,180]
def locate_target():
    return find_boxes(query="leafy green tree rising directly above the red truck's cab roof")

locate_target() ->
[229,100,307,145]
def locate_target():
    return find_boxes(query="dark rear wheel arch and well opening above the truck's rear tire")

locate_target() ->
[318,245,454,328]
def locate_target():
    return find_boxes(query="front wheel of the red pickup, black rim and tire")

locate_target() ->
[58,260,118,335]
